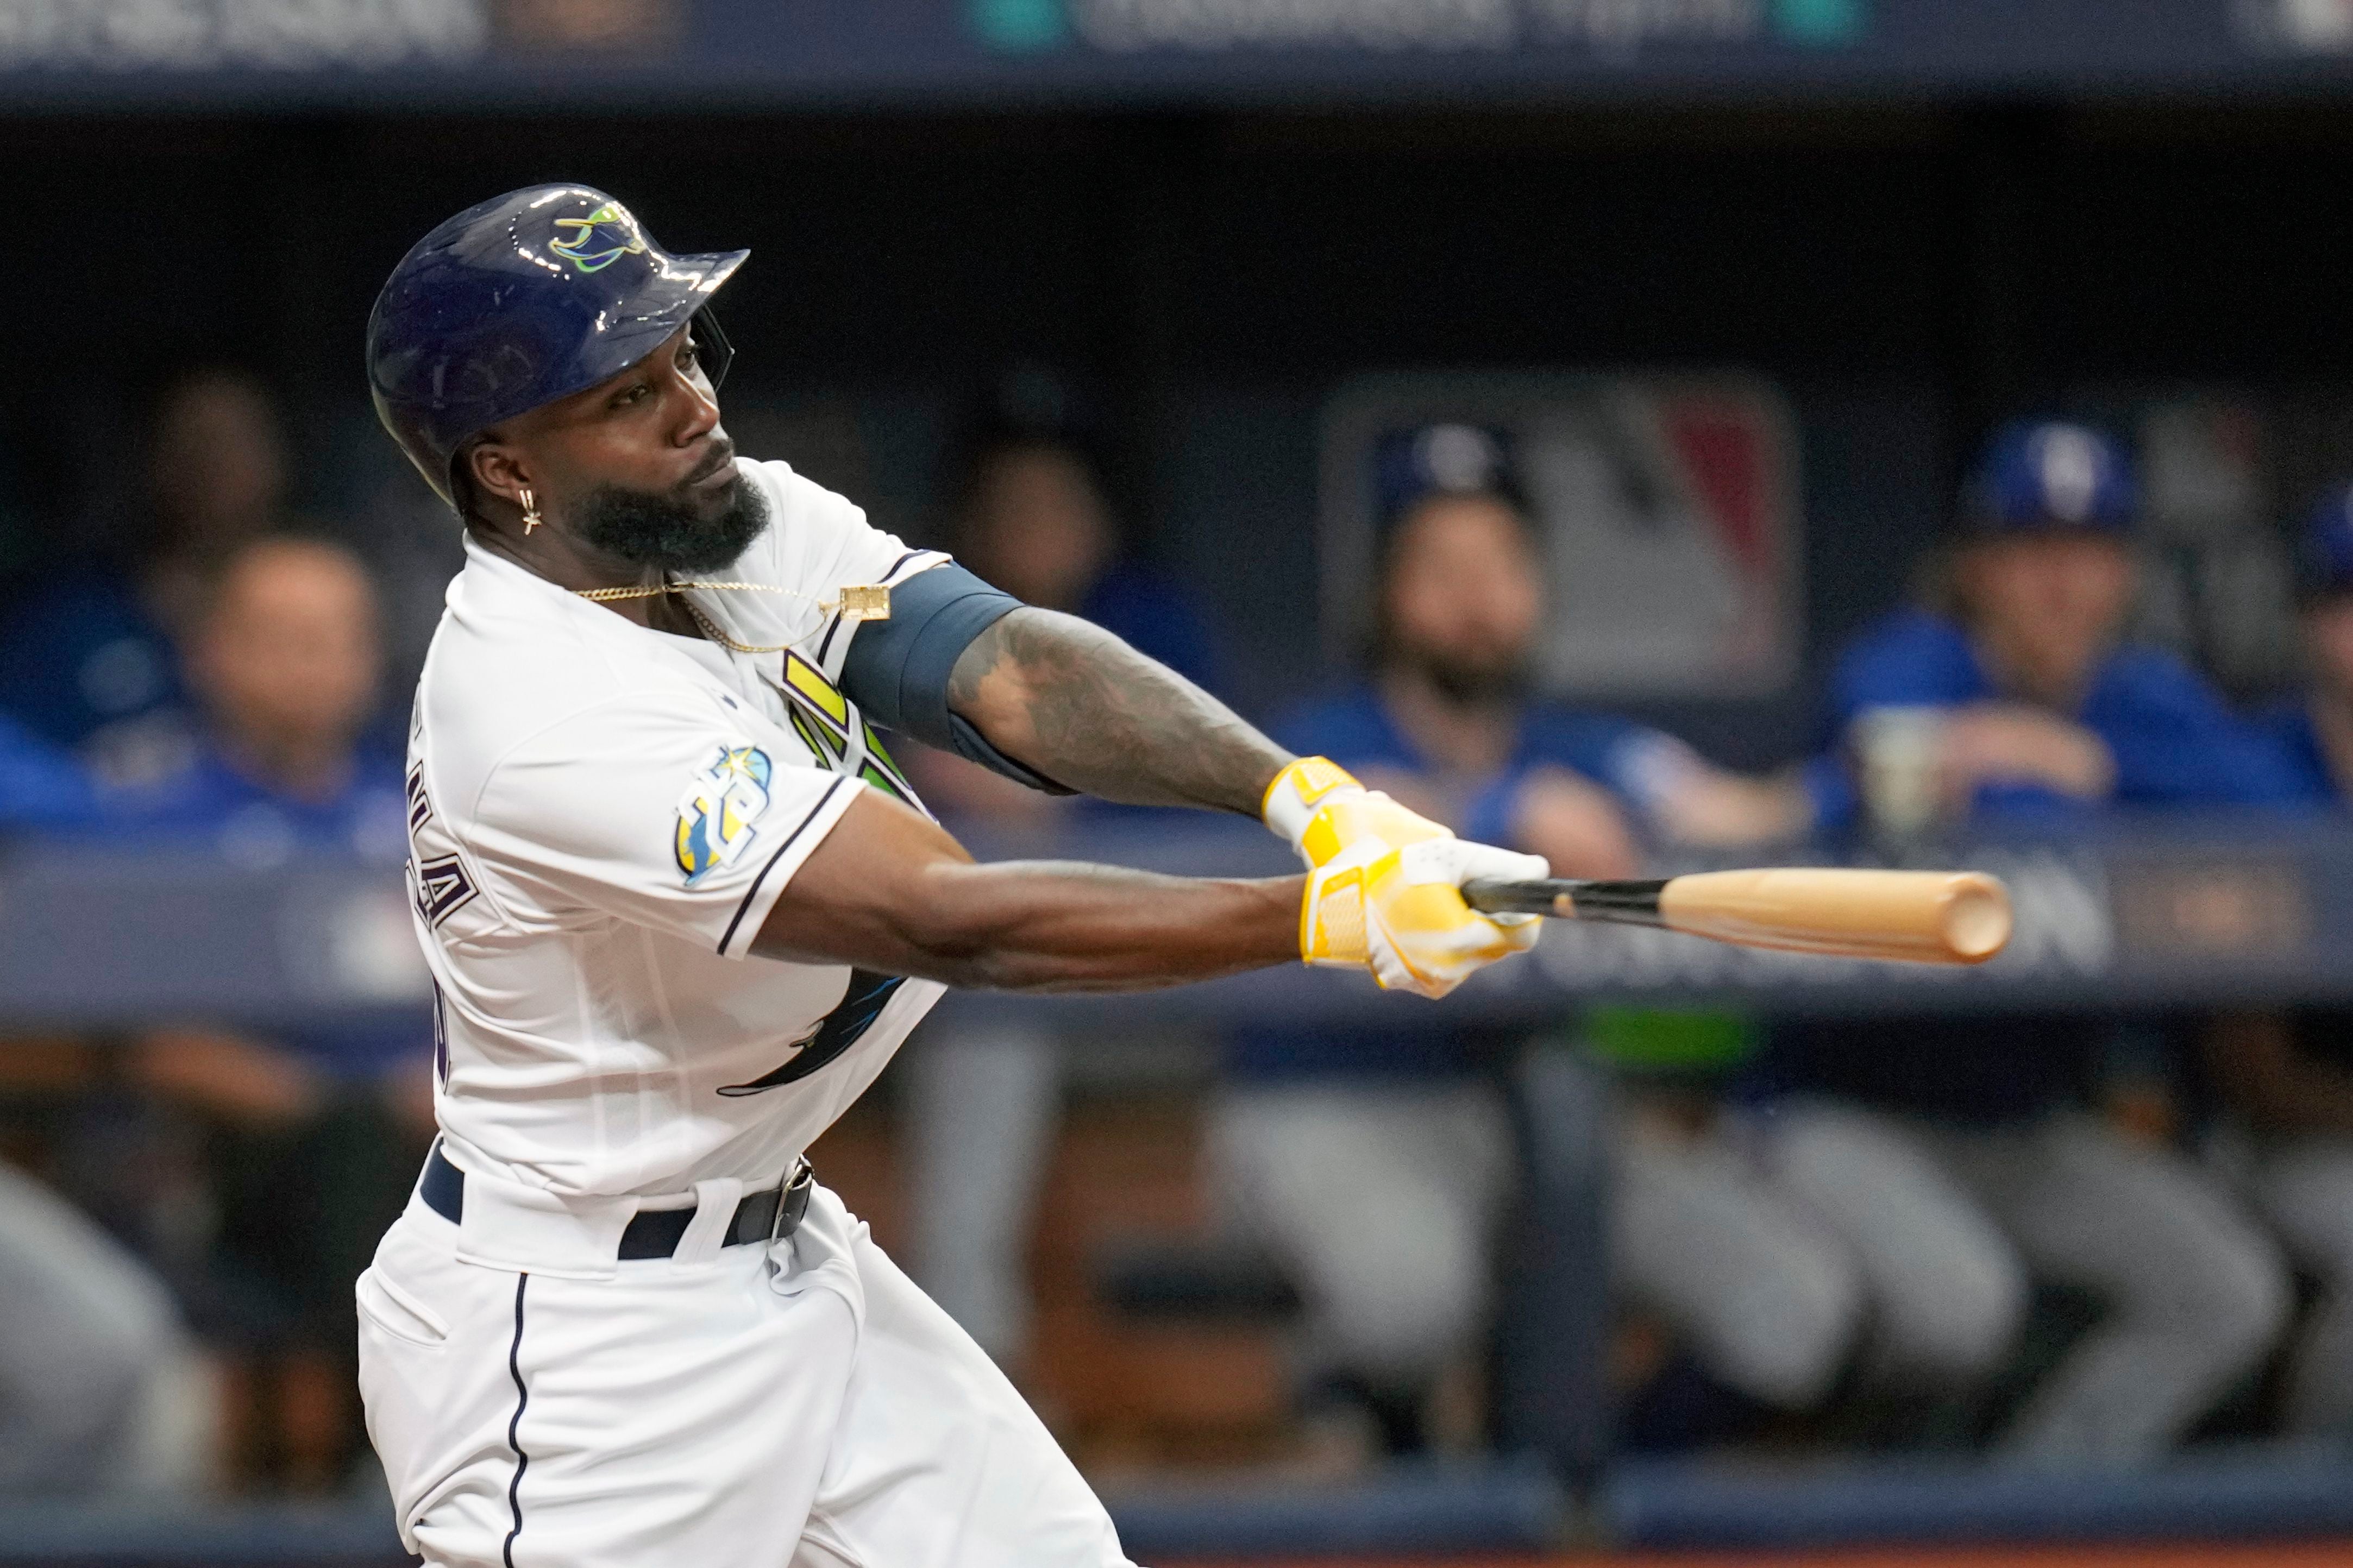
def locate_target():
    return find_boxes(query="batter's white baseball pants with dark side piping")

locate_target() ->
[357,1187,1127,1568]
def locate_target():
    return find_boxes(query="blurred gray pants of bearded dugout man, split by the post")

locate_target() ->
[1212,1081,1863,1408]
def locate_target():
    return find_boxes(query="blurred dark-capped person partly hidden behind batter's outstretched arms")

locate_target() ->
[899,418,1223,1373]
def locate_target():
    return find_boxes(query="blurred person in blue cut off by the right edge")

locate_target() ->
[2205,489,2353,1437]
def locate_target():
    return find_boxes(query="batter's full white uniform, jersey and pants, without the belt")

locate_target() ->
[357,463,1130,1568]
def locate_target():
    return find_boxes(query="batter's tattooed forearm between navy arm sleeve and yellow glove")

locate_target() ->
[948,609,1292,816]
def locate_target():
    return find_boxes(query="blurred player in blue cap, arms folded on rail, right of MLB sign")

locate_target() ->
[1762,423,2292,1465]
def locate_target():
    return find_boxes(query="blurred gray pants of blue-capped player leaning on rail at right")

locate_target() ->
[1760,1100,2289,1465]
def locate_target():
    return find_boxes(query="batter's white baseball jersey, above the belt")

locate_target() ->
[407,463,946,1197]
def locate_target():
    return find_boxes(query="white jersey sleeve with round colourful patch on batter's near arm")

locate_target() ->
[470,694,866,959]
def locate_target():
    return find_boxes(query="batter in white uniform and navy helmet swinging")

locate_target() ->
[357,186,1546,1568]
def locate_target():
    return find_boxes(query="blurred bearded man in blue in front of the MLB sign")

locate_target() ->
[1209,425,1825,1458]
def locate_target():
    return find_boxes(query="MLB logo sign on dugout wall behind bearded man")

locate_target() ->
[1317,371,1805,701]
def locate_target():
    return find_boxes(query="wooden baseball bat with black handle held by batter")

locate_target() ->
[1464,865,2010,964]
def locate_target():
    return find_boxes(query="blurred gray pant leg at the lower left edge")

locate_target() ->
[0,1164,209,1495]
